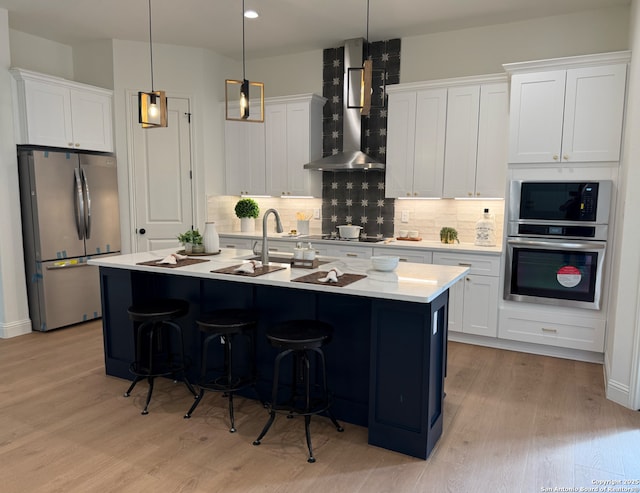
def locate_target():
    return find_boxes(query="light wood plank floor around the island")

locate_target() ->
[0,322,640,493]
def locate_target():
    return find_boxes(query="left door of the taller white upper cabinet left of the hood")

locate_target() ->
[264,104,289,197]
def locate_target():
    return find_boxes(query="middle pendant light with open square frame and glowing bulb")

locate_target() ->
[224,0,264,122]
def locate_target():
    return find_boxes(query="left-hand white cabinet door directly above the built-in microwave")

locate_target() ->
[509,70,566,163]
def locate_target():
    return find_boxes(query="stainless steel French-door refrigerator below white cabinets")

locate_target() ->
[18,146,120,331]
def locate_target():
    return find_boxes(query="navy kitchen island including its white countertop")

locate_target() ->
[90,249,468,459]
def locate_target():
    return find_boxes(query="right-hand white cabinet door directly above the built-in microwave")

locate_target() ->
[562,64,627,162]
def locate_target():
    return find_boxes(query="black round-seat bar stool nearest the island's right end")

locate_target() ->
[253,320,344,462]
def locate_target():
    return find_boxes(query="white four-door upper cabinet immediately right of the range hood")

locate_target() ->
[386,75,508,198]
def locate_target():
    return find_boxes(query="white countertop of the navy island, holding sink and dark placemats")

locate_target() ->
[89,248,469,303]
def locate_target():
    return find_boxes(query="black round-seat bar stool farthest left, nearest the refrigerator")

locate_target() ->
[124,298,198,414]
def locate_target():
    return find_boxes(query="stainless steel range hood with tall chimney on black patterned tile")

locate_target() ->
[304,38,384,171]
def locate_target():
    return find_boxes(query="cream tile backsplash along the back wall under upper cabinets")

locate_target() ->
[208,194,504,243]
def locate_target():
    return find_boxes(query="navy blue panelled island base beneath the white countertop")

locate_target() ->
[100,266,448,459]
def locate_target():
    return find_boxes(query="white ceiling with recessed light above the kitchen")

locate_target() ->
[0,0,630,59]
